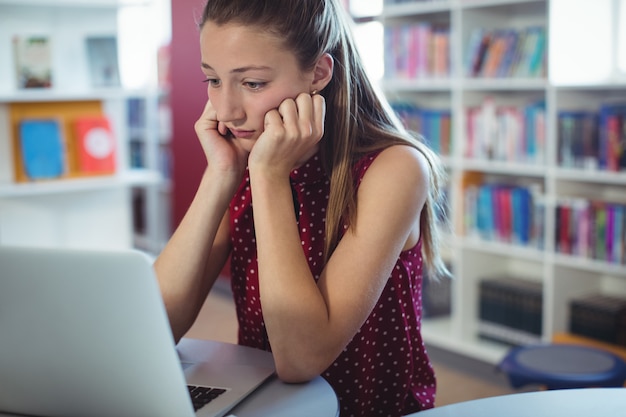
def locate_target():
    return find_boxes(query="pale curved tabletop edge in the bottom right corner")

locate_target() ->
[407,388,626,417]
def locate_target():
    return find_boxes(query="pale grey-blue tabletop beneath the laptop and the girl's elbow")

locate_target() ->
[177,339,339,417]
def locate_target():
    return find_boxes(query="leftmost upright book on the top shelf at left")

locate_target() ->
[13,35,52,89]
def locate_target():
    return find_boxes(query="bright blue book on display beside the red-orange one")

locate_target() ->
[19,119,66,180]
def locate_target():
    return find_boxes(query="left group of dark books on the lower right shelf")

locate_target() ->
[478,276,543,345]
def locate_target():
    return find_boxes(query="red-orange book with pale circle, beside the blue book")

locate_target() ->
[74,116,116,174]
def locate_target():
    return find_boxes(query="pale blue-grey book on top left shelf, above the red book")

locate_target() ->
[85,36,120,87]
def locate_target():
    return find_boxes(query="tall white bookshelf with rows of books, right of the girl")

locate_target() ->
[377,0,626,364]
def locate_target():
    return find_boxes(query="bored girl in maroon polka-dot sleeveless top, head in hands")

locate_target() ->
[155,0,447,416]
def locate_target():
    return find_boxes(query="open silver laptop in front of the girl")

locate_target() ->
[0,246,275,417]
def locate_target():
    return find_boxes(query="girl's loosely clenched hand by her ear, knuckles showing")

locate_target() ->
[248,93,326,176]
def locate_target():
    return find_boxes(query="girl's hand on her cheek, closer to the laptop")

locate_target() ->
[194,100,248,179]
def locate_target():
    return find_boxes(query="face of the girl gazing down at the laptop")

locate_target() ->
[200,21,314,150]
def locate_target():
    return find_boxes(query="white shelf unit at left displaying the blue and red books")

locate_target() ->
[0,0,169,252]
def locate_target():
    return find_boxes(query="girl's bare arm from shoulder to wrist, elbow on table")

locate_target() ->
[250,94,428,382]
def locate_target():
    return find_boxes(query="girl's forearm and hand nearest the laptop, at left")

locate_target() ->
[154,102,247,342]
